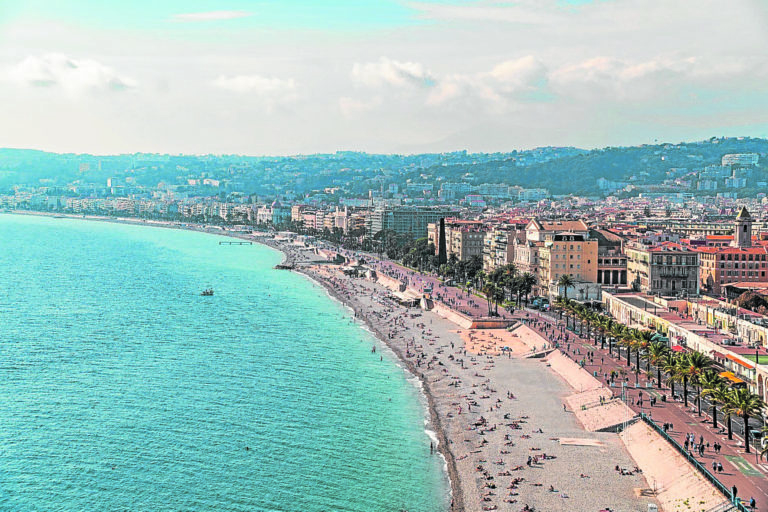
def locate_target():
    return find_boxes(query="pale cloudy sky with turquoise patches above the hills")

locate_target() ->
[0,0,768,155]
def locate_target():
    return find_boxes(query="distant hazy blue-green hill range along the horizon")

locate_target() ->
[0,137,768,195]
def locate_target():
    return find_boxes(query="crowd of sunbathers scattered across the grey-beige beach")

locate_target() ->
[281,243,642,511]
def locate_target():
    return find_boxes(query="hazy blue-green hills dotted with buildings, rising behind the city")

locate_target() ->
[0,138,768,200]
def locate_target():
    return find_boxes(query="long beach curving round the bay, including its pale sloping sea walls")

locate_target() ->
[16,216,718,512]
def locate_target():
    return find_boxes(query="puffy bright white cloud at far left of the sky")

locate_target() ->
[6,53,137,94]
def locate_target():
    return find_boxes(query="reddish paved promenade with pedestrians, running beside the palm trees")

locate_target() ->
[340,247,768,510]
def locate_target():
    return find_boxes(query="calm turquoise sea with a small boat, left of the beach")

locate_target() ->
[0,214,449,512]
